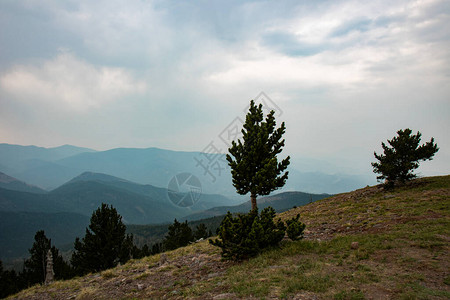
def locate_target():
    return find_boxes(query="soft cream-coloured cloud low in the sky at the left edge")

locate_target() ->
[0,52,146,112]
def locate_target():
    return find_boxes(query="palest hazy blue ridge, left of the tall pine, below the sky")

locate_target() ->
[57,148,235,196]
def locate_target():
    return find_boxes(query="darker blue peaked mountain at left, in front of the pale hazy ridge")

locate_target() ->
[0,172,236,259]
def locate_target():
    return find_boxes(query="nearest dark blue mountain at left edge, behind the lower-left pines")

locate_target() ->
[0,211,89,260]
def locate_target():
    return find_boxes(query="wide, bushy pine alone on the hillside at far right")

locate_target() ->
[372,128,439,186]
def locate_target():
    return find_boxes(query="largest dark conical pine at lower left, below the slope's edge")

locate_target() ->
[71,203,133,274]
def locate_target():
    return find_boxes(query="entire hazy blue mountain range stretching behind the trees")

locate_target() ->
[0,144,364,258]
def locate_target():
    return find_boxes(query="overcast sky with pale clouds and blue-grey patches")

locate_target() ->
[0,0,450,175]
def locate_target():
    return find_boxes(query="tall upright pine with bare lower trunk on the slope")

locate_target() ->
[227,100,290,210]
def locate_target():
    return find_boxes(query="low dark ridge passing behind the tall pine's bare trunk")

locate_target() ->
[185,192,331,221]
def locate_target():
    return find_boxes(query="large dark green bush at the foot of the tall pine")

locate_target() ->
[210,207,286,260]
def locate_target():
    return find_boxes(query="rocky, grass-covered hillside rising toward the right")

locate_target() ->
[8,176,450,299]
